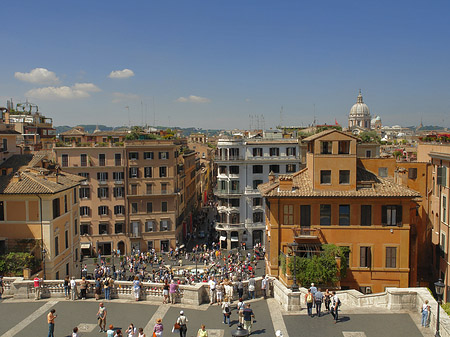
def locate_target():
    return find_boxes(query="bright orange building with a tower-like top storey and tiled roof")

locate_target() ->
[259,130,420,293]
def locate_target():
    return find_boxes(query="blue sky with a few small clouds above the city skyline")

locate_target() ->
[0,0,450,129]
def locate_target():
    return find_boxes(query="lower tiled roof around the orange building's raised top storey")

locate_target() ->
[258,167,420,198]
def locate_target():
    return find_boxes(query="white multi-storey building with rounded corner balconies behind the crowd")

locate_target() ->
[215,137,305,249]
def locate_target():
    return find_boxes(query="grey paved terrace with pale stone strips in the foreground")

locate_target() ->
[0,299,433,337]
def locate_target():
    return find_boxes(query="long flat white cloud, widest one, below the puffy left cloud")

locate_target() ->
[25,83,101,100]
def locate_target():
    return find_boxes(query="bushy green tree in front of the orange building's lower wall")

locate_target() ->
[288,244,350,286]
